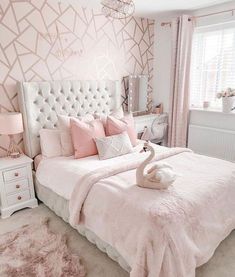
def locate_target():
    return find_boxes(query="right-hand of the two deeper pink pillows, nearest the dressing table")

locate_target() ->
[106,114,137,146]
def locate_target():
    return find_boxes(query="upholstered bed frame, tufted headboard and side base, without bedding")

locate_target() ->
[17,80,130,271]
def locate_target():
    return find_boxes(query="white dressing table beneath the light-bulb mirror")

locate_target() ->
[134,114,168,146]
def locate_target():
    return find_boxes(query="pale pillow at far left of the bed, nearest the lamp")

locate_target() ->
[39,129,62,158]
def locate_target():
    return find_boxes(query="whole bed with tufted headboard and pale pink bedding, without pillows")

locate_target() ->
[18,78,235,277]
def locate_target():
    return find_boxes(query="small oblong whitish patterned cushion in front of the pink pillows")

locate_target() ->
[95,132,133,160]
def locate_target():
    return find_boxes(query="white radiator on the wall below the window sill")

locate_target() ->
[188,125,235,162]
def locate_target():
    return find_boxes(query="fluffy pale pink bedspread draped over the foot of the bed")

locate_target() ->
[70,146,235,277]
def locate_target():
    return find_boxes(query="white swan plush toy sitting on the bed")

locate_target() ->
[136,142,177,189]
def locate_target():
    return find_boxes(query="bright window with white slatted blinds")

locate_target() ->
[190,23,235,108]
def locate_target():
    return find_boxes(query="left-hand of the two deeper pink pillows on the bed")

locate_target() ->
[70,118,105,159]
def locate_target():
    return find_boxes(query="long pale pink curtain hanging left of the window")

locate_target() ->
[168,15,194,147]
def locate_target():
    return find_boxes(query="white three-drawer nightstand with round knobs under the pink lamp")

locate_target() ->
[0,155,38,218]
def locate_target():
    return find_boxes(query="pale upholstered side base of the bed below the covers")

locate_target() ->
[34,174,131,272]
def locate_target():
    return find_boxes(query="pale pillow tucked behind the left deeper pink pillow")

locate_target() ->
[58,114,94,156]
